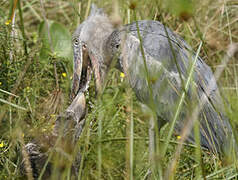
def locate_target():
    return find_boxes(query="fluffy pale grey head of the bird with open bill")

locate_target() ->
[72,4,114,93]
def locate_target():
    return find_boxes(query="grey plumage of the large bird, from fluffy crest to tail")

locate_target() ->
[72,7,232,153]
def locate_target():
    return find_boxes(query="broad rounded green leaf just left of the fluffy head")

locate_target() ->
[39,21,72,59]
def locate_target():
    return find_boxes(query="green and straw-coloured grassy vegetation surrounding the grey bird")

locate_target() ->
[0,0,238,179]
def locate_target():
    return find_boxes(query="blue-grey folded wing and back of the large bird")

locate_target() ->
[116,20,232,153]
